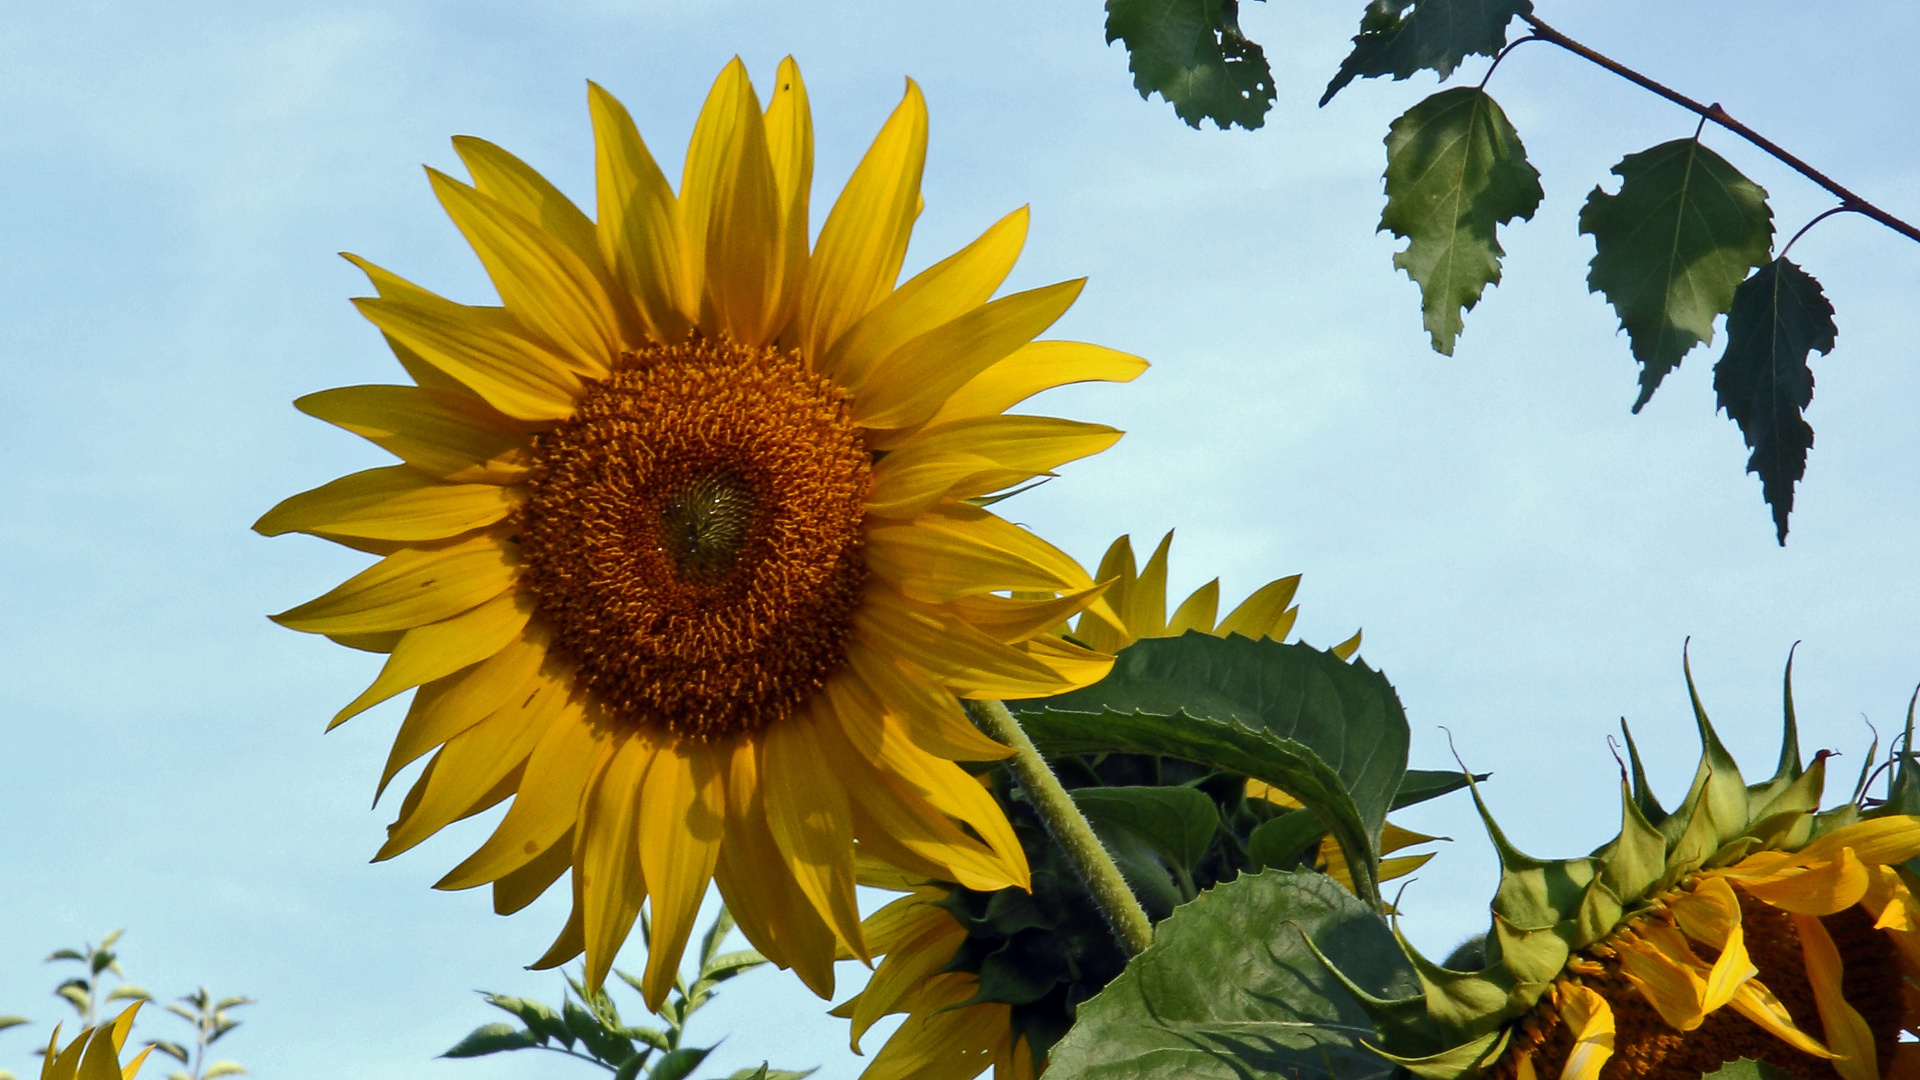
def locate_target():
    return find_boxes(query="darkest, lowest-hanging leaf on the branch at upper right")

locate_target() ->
[1713,256,1839,548]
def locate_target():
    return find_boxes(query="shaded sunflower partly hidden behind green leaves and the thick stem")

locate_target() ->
[833,532,1390,1080]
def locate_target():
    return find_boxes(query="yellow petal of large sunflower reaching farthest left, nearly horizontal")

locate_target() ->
[253,465,522,540]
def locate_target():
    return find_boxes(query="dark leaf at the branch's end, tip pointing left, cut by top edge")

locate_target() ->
[1321,0,1534,106]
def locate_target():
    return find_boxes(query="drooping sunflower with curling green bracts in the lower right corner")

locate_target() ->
[1348,657,1920,1080]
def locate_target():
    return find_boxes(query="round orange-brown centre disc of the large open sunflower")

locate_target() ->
[520,340,872,738]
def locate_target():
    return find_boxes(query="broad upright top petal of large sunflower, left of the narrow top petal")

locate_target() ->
[689,58,785,346]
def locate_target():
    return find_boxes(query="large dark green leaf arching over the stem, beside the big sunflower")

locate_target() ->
[1008,632,1407,899]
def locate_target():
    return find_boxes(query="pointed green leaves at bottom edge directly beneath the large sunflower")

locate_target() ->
[442,907,814,1080]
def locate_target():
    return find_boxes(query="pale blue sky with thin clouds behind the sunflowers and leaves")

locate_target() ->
[0,0,1920,1080]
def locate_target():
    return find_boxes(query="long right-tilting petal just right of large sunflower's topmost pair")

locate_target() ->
[797,79,927,363]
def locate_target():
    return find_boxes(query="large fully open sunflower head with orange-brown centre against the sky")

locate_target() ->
[255,58,1144,1007]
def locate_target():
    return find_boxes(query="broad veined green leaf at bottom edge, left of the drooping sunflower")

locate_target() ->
[1046,871,1421,1080]
